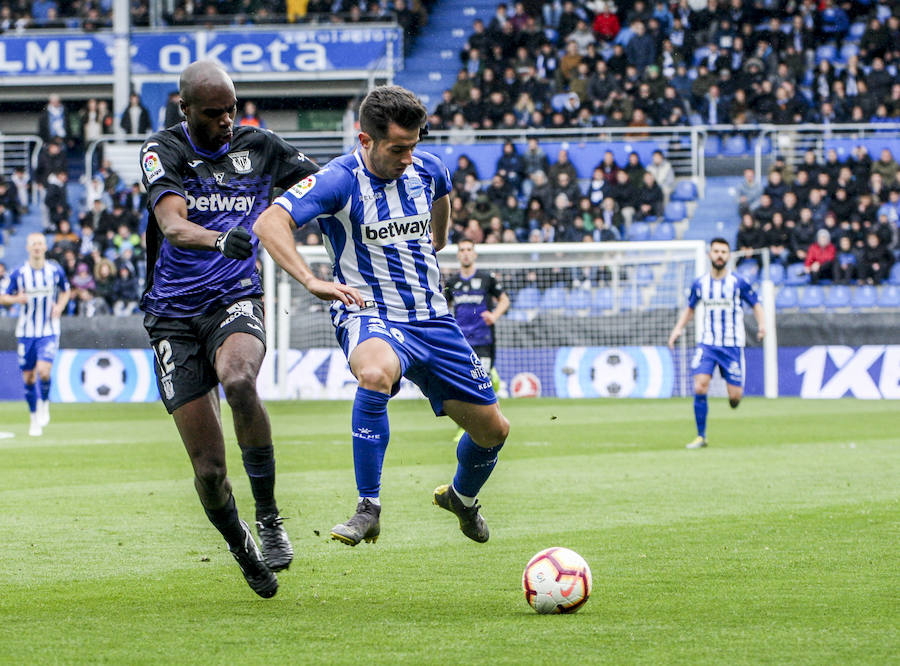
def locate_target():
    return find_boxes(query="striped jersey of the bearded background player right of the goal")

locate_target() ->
[688,273,759,347]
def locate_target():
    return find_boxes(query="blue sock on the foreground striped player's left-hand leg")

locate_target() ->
[353,388,391,497]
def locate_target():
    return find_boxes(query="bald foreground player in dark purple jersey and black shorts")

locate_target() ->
[140,61,317,597]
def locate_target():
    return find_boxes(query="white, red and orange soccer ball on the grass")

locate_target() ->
[522,547,592,615]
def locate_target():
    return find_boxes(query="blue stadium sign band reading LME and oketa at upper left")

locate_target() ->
[0,27,401,80]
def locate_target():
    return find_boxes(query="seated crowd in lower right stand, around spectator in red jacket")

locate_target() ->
[735,145,900,285]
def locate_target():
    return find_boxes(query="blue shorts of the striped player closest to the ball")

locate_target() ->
[335,315,497,416]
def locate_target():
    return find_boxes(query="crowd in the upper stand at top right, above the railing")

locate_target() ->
[431,0,900,132]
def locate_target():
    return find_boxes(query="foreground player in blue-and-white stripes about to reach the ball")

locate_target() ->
[253,86,509,546]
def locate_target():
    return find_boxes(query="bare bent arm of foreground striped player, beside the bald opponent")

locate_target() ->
[253,205,364,307]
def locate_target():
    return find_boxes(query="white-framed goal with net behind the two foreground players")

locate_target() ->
[264,241,707,399]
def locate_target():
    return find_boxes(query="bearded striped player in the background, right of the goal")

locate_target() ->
[669,238,766,449]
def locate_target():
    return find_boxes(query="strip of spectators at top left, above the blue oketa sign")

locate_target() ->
[0,0,434,31]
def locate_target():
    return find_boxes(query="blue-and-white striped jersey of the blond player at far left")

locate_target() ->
[6,259,69,338]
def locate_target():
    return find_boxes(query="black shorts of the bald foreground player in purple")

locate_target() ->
[144,297,266,414]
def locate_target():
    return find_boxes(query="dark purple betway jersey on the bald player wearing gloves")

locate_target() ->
[140,122,318,317]
